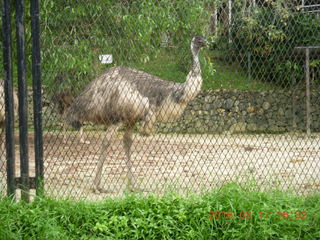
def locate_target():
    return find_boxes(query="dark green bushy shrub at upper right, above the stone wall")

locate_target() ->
[224,1,320,86]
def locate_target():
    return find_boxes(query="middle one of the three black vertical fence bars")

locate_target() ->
[16,0,29,201]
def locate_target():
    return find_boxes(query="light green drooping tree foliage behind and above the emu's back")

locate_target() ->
[41,0,214,94]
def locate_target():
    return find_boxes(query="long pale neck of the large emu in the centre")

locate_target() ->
[183,49,202,102]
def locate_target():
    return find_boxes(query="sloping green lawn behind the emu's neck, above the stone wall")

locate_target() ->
[132,52,275,90]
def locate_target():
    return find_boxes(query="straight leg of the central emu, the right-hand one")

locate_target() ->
[123,127,135,191]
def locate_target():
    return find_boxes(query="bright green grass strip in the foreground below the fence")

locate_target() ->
[0,185,320,240]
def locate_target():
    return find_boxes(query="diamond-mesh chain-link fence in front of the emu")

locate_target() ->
[0,0,320,200]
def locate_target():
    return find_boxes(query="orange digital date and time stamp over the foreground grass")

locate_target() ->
[208,210,308,220]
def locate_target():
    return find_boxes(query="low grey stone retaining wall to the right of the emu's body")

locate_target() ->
[157,90,320,133]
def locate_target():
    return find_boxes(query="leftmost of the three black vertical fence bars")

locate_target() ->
[2,0,15,197]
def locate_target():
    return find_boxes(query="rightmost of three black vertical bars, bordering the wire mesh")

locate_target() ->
[30,0,44,195]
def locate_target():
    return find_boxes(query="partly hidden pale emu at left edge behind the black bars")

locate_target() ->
[0,79,18,171]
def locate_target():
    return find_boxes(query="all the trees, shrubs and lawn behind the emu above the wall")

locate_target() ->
[0,0,320,92]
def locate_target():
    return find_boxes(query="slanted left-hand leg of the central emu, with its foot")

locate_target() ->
[93,124,121,192]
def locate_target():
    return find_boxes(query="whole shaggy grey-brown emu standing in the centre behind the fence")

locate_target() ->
[67,35,207,192]
